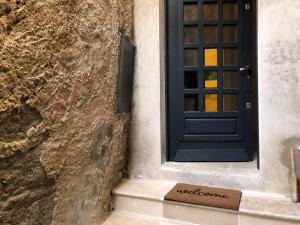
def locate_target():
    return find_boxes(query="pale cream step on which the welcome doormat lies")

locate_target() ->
[113,180,300,225]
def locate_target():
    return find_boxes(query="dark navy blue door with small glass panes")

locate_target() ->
[167,0,252,162]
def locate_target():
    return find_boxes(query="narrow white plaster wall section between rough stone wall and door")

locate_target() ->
[129,0,163,177]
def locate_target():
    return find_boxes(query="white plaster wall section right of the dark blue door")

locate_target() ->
[258,0,300,193]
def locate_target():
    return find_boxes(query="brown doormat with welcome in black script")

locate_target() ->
[164,183,242,210]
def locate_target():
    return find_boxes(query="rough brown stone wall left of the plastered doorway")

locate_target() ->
[0,0,133,225]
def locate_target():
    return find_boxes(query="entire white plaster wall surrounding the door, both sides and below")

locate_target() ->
[129,0,300,195]
